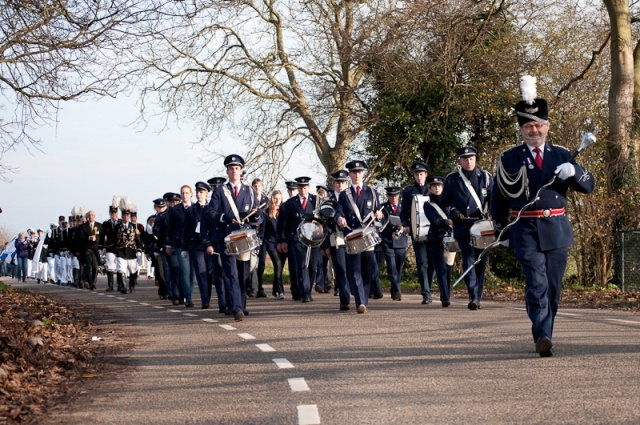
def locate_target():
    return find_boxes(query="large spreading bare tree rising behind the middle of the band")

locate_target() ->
[131,0,420,178]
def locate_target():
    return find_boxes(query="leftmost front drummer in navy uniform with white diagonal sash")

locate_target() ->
[210,155,260,321]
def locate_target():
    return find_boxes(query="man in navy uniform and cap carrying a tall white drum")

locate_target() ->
[401,162,433,304]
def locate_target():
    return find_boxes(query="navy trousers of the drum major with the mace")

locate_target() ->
[515,247,568,342]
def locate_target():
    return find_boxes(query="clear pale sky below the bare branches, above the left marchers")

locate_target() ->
[0,97,325,232]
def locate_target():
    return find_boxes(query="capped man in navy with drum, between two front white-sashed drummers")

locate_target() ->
[278,177,316,303]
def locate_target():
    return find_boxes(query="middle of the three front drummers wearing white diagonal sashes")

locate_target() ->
[336,161,382,314]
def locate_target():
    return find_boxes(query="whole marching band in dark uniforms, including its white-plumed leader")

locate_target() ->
[5,77,595,357]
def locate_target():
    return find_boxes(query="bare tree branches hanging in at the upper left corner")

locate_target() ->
[0,0,140,180]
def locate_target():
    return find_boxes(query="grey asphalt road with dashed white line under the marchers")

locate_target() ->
[9,278,640,425]
